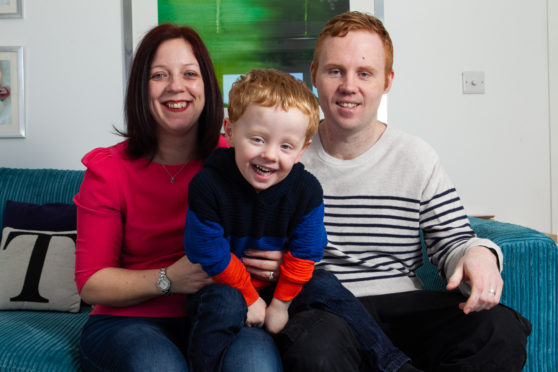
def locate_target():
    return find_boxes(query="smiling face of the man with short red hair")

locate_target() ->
[311,31,393,132]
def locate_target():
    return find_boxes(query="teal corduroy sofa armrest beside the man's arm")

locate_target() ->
[470,217,558,371]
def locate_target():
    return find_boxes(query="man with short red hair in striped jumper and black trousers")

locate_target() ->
[279,12,531,371]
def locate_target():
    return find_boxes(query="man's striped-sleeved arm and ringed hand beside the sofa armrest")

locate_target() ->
[420,148,503,314]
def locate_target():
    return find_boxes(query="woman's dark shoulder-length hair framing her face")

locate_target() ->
[119,24,224,160]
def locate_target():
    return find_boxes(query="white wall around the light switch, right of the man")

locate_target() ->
[384,0,556,232]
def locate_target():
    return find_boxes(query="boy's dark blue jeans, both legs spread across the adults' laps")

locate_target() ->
[187,269,409,371]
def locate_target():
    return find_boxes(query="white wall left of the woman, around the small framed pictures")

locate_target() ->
[0,0,123,169]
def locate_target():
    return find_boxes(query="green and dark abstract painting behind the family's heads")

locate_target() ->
[158,0,350,104]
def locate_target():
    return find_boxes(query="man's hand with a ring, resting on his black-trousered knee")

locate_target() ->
[446,246,504,314]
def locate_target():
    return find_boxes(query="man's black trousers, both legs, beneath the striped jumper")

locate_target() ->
[280,290,531,372]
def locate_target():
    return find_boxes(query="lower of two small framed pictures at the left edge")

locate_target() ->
[0,46,25,137]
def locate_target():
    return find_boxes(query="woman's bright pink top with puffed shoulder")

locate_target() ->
[74,141,224,317]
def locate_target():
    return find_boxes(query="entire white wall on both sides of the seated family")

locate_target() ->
[0,0,558,232]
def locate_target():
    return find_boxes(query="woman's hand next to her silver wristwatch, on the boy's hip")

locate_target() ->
[167,256,213,294]
